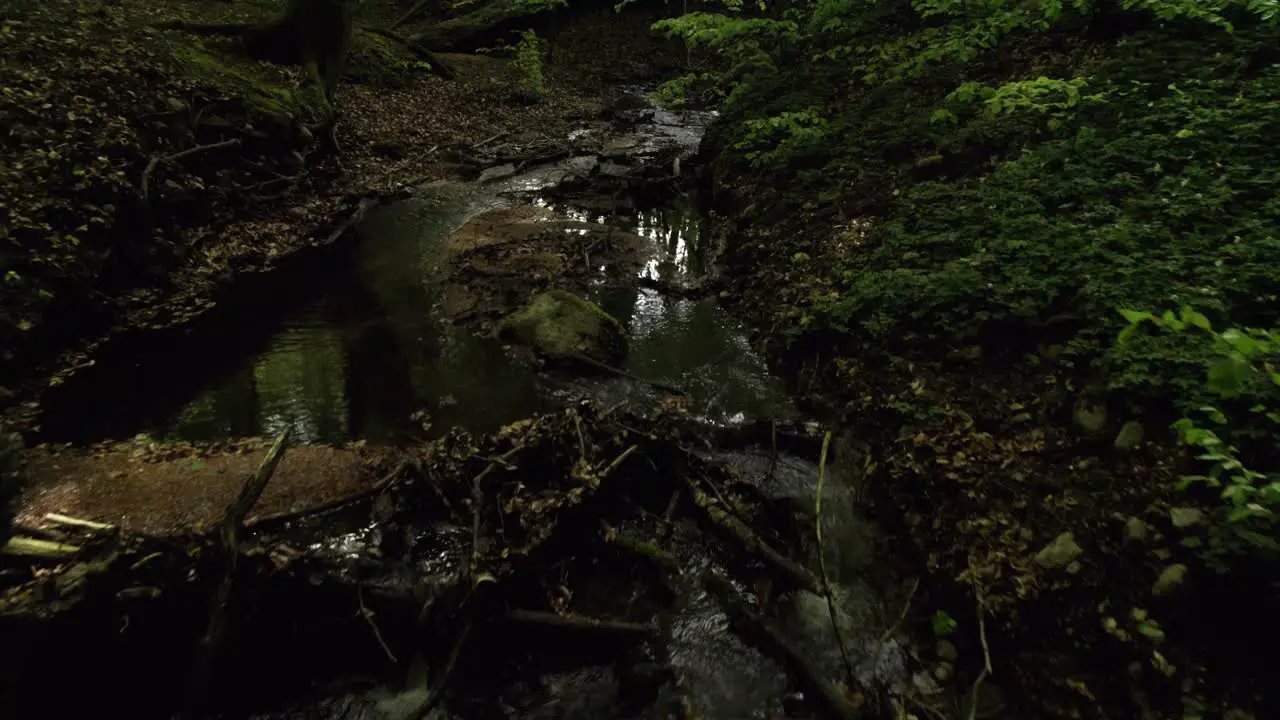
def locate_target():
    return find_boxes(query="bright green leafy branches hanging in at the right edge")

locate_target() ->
[1119,307,1280,568]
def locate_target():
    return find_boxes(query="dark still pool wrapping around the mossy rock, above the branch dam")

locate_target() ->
[51,170,790,443]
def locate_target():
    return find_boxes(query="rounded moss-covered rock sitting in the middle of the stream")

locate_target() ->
[499,290,627,363]
